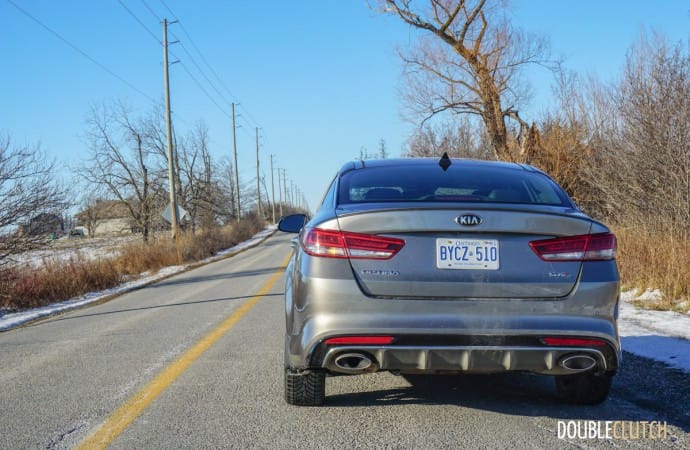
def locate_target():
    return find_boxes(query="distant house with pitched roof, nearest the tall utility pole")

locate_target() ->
[75,200,134,236]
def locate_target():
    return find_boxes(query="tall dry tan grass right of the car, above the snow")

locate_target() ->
[614,227,690,312]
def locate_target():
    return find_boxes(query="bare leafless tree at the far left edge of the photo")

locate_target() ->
[0,135,68,267]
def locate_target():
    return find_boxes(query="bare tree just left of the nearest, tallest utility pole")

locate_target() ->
[82,103,165,242]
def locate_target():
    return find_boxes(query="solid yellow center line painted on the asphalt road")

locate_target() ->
[77,251,290,450]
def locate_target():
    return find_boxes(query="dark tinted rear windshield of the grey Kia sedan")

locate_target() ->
[338,164,572,207]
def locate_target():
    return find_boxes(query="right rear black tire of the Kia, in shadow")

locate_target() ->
[555,372,613,405]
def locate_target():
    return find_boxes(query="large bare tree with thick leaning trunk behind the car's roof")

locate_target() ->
[379,0,548,160]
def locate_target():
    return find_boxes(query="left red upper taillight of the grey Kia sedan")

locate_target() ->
[302,228,405,259]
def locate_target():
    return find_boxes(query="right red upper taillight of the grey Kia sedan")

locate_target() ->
[529,233,616,261]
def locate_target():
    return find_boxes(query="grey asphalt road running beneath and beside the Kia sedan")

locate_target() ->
[0,234,690,449]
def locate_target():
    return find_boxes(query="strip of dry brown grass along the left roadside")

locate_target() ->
[0,218,263,310]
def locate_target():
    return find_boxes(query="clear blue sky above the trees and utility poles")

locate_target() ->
[0,0,690,208]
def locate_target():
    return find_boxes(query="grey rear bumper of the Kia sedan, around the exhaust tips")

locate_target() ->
[285,279,621,375]
